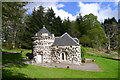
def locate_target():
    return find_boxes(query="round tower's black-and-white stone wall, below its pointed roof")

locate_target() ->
[33,36,54,63]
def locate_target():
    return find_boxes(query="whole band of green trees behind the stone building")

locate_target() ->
[2,2,118,49]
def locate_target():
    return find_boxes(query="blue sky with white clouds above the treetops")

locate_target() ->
[25,1,118,22]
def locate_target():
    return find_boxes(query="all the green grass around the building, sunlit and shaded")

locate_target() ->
[2,48,120,78]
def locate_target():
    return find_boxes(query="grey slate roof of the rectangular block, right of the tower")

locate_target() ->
[53,33,79,46]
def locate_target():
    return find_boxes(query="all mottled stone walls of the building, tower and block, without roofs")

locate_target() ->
[33,36,81,64]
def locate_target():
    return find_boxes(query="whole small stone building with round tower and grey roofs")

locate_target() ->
[33,27,81,64]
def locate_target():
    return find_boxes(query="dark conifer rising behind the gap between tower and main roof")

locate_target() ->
[45,8,64,36]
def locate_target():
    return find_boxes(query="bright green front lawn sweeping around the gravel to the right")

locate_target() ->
[3,55,118,78]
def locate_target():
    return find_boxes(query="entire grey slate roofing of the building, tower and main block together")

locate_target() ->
[35,26,79,46]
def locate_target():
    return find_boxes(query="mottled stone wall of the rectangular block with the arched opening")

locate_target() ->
[51,46,81,64]
